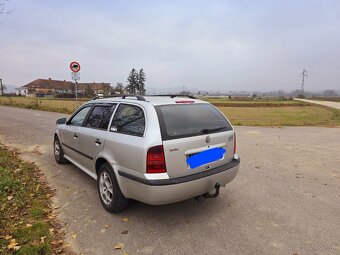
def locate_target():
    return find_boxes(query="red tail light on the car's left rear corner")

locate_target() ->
[146,145,166,173]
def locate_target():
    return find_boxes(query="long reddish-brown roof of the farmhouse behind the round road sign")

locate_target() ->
[22,79,110,90]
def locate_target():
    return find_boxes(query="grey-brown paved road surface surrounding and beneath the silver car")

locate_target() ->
[0,107,340,255]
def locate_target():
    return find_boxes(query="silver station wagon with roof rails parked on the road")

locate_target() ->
[54,95,240,212]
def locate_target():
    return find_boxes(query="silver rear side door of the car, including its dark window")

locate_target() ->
[78,103,117,172]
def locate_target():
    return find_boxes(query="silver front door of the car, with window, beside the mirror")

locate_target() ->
[59,105,91,162]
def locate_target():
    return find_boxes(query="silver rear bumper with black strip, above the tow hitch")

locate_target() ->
[117,158,240,205]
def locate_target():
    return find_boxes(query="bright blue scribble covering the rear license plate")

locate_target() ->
[187,148,227,169]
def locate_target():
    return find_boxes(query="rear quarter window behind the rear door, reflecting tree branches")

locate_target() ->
[110,104,145,136]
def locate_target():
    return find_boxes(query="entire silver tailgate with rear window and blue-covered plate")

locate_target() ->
[156,103,234,178]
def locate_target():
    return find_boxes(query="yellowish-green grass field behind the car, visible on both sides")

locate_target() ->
[0,97,340,127]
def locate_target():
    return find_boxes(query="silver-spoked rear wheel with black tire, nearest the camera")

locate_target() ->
[97,163,129,213]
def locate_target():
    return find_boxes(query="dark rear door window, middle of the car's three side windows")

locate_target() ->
[86,104,116,130]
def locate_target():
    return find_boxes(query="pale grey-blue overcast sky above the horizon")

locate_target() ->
[0,0,340,91]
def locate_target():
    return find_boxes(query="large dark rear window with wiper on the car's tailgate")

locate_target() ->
[156,104,232,140]
